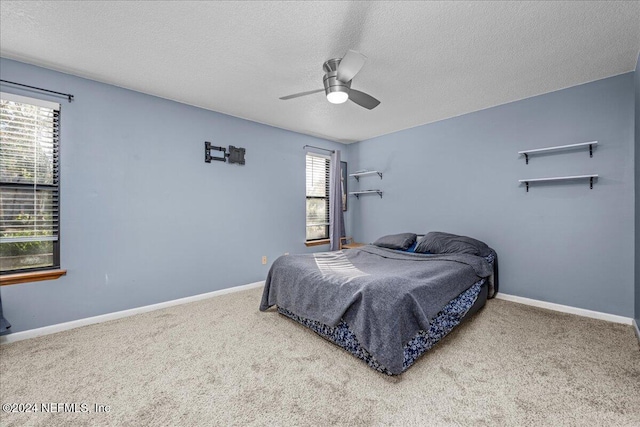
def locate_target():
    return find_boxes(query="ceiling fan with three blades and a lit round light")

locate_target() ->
[280,50,380,110]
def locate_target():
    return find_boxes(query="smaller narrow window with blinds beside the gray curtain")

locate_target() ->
[307,153,330,241]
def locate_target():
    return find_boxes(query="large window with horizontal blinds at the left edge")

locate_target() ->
[0,93,60,274]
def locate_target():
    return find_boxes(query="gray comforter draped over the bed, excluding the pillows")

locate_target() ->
[260,246,493,374]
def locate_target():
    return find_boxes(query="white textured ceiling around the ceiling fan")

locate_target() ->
[0,0,640,142]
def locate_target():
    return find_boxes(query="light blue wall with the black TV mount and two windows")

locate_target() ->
[0,59,349,332]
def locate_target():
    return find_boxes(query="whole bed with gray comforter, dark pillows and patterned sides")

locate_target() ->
[260,232,498,375]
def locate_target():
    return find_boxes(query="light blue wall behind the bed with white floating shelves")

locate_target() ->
[349,73,634,317]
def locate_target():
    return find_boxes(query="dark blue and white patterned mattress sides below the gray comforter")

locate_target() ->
[278,279,487,375]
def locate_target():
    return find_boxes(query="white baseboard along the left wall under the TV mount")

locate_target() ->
[0,280,264,344]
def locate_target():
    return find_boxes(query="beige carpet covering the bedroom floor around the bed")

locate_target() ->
[0,289,640,426]
